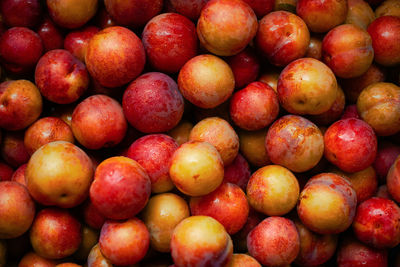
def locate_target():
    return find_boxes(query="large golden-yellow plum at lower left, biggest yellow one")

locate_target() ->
[25,141,93,208]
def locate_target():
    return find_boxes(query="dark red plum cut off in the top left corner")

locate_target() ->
[0,0,42,28]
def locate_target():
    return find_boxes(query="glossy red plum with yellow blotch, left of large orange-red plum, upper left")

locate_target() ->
[35,49,89,104]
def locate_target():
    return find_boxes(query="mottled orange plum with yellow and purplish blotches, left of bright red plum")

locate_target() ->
[265,115,324,172]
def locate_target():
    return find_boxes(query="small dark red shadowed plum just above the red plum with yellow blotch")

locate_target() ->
[37,17,64,52]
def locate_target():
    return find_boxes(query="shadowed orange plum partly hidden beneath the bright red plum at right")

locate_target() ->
[332,166,378,203]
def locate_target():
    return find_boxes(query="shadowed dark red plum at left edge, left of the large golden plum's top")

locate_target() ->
[0,131,30,167]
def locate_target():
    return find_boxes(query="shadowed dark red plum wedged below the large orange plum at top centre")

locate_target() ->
[226,46,261,89]
